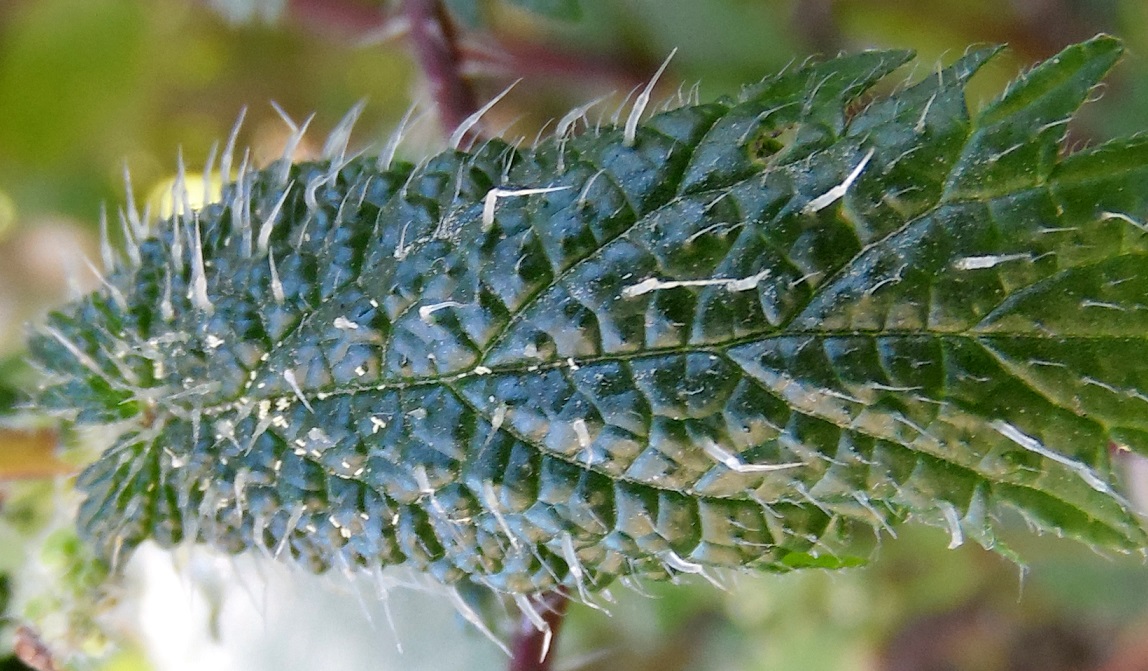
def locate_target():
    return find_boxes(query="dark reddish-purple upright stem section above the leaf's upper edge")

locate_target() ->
[403,0,479,134]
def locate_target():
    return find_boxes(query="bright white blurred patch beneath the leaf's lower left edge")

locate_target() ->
[130,543,506,671]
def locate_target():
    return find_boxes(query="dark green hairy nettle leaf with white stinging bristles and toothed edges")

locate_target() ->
[24,37,1148,596]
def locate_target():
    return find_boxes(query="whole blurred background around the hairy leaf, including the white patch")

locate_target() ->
[0,0,1148,671]
